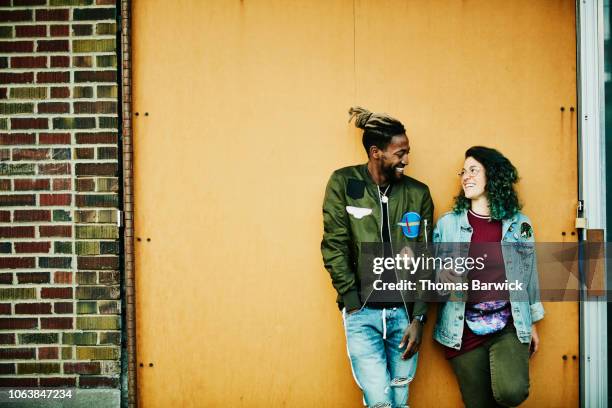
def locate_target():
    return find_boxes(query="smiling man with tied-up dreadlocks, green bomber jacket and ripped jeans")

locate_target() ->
[321,107,433,408]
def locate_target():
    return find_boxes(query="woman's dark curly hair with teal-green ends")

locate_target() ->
[453,146,521,220]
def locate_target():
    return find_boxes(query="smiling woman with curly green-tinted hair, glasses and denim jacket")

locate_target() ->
[433,146,544,408]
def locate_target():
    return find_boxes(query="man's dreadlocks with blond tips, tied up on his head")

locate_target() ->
[349,106,406,154]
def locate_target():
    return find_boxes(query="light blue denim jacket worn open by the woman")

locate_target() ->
[433,210,544,350]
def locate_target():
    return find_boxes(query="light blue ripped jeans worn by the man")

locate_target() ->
[342,307,418,408]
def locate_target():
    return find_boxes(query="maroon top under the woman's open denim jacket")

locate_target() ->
[444,210,512,359]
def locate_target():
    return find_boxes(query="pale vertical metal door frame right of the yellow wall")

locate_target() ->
[576,0,608,407]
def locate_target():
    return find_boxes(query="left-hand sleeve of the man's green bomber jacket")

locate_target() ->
[321,173,361,310]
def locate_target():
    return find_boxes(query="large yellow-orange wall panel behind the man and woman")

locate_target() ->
[133,0,578,407]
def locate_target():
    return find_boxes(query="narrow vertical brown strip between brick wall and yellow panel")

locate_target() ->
[120,0,138,407]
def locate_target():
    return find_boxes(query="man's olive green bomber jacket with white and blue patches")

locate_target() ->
[321,164,434,315]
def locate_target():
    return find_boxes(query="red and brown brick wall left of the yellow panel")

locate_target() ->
[0,0,121,388]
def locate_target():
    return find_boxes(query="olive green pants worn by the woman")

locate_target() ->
[450,324,529,408]
